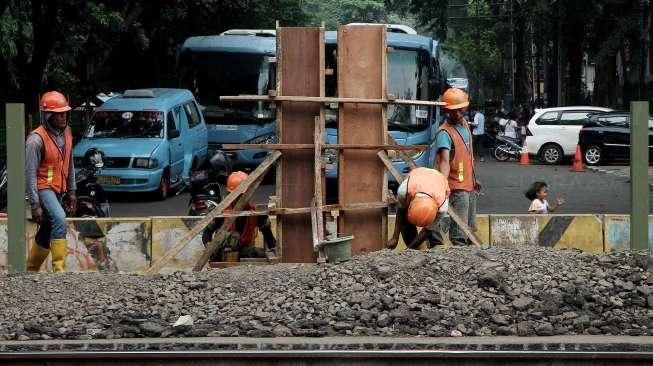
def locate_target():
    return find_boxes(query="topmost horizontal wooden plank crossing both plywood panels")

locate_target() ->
[220,95,446,106]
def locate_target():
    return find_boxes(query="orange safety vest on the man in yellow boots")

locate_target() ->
[33,126,73,193]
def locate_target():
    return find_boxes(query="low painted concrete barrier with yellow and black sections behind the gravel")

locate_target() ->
[0,215,653,273]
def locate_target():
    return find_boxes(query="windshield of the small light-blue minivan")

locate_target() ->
[86,111,164,138]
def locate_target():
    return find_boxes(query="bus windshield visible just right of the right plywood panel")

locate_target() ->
[388,49,429,131]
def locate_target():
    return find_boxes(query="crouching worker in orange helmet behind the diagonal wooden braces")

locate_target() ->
[202,171,277,262]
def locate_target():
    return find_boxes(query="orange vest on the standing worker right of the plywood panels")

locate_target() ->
[438,121,474,192]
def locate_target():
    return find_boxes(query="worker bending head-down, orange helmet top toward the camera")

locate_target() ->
[387,168,449,249]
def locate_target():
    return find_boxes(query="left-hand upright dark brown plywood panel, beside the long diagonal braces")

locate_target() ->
[277,28,324,262]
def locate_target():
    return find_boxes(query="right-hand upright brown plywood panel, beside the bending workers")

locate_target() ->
[338,25,387,254]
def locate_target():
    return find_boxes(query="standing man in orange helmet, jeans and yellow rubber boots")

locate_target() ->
[25,91,77,272]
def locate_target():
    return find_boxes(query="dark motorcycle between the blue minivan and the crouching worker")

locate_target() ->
[188,151,231,216]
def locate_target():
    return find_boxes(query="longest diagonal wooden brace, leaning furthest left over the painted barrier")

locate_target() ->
[145,151,281,274]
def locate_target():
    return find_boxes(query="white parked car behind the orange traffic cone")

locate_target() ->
[526,107,611,164]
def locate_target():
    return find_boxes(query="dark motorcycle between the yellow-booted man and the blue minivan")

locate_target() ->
[64,148,111,217]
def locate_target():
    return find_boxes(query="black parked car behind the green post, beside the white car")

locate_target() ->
[578,112,653,165]
